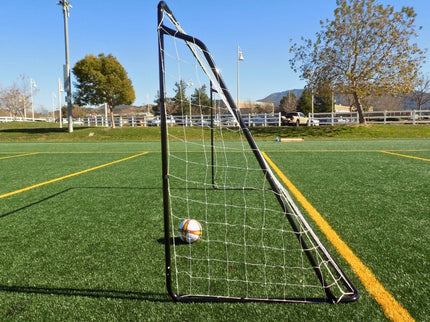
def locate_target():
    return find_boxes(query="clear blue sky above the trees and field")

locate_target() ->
[0,0,430,110]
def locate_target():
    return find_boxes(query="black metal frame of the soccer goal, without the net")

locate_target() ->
[157,1,360,303]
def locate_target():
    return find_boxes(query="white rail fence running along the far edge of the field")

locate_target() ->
[0,110,430,127]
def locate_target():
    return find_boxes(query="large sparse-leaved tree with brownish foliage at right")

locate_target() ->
[290,0,425,123]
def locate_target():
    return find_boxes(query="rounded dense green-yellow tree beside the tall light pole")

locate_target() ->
[73,54,136,127]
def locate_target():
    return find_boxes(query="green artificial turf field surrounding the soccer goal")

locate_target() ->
[0,139,430,321]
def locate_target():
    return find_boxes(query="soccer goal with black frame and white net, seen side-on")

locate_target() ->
[158,2,359,303]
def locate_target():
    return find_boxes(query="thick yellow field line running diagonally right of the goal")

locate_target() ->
[262,152,414,321]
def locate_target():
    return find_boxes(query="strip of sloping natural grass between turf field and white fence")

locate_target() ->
[0,122,430,142]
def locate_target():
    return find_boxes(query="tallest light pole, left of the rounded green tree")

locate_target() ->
[57,0,73,133]
